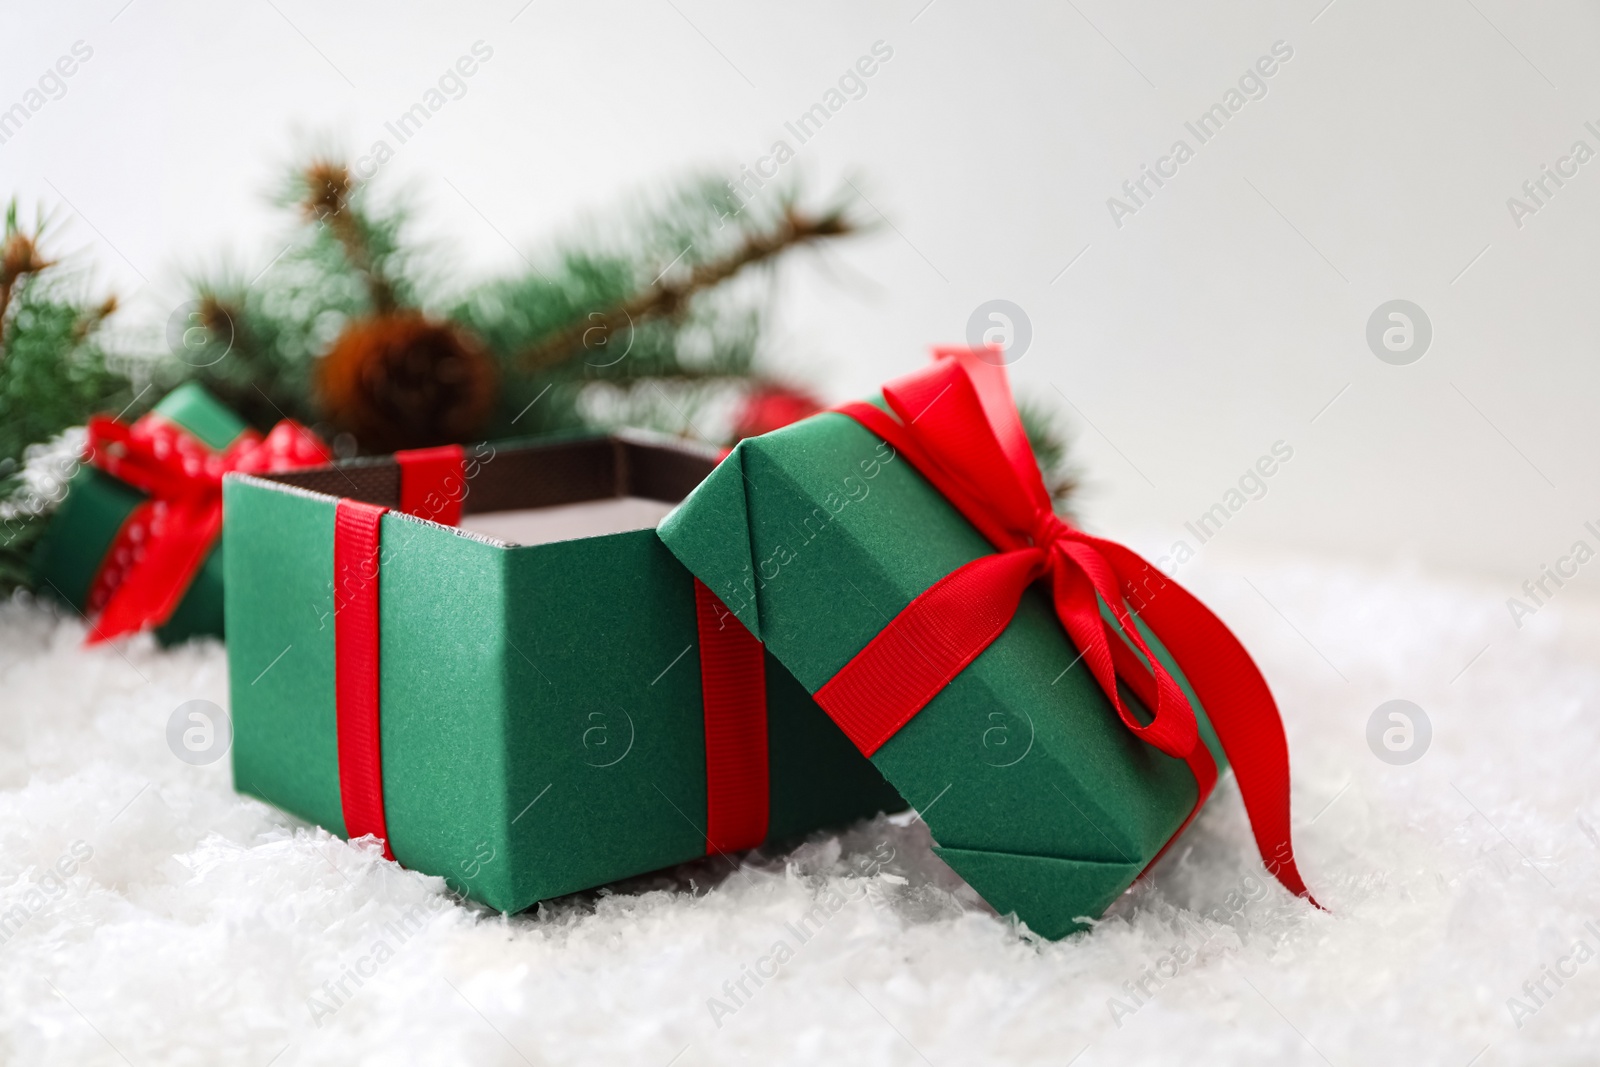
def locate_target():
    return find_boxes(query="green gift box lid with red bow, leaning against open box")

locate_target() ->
[659,350,1304,937]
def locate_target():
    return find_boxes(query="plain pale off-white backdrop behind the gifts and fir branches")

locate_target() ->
[0,0,1600,597]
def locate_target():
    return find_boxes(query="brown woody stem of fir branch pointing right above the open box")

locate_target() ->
[515,208,856,371]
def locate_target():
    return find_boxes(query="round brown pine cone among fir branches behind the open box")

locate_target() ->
[318,310,496,453]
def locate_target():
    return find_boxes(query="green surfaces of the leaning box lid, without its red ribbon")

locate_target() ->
[659,414,1226,937]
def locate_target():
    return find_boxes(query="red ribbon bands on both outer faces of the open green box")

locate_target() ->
[324,499,770,859]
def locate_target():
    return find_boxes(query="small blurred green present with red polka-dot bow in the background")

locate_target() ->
[34,382,331,645]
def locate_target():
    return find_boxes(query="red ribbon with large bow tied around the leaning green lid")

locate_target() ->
[816,349,1310,896]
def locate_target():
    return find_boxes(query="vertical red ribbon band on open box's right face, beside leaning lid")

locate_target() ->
[694,579,770,854]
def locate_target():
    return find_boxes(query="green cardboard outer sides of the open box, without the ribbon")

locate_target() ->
[224,438,904,912]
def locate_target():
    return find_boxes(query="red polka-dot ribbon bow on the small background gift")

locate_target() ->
[85,411,333,645]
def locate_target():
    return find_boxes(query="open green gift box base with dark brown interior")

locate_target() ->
[222,437,904,912]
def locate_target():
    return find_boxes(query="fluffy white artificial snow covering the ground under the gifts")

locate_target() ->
[0,550,1600,1067]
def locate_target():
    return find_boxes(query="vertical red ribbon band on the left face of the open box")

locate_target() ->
[333,499,394,859]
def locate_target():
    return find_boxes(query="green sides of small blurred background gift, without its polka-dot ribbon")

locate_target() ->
[34,382,245,645]
